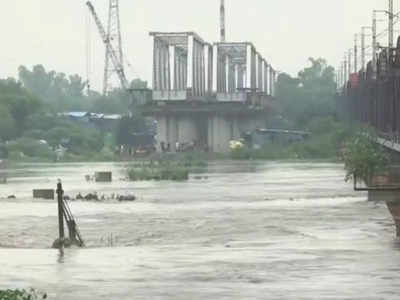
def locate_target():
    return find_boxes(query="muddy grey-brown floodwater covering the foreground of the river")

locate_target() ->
[0,161,400,300]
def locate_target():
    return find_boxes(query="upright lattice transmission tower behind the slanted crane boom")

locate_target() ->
[103,0,124,95]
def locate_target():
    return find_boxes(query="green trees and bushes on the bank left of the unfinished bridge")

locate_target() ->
[0,65,147,160]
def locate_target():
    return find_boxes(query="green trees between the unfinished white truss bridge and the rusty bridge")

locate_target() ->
[232,58,351,159]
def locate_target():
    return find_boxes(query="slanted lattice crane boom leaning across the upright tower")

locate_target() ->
[86,1,129,90]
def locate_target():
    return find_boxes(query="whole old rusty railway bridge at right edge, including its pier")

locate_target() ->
[337,37,400,237]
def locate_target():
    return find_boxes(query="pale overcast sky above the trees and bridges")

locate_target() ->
[0,0,400,89]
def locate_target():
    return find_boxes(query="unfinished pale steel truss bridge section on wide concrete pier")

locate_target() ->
[144,32,276,152]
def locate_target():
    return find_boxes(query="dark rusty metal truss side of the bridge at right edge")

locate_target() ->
[339,37,400,141]
